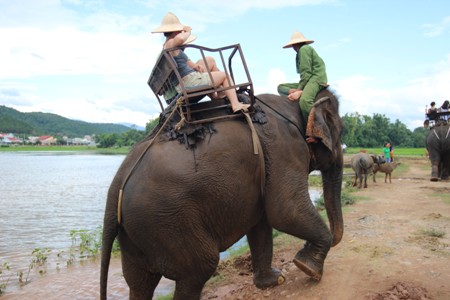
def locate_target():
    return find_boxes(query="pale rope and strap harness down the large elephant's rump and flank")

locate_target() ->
[117,97,266,224]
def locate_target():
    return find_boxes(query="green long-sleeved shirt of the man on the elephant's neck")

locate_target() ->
[296,45,328,90]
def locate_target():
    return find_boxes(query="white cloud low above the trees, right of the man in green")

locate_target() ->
[332,55,450,130]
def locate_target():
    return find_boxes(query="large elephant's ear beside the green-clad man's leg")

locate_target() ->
[306,97,342,159]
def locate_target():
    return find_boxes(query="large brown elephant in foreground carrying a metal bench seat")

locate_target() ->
[100,90,344,299]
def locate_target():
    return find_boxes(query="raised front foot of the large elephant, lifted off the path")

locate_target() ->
[294,243,325,281]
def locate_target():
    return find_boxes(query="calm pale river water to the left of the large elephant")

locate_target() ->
[0,152,318,300]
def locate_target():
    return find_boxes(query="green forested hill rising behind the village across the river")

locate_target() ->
[0,105,133,137]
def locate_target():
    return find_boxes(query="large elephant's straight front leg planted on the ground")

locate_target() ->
[247,217,285,289]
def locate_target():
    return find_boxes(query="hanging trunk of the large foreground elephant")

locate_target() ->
[322,156,344,246]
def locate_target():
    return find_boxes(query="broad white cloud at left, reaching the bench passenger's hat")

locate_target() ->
[0,27,160,78]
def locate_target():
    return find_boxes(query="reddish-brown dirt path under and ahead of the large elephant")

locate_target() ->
[202,158,450,300]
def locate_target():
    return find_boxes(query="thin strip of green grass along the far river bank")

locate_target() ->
[0,145,130,154]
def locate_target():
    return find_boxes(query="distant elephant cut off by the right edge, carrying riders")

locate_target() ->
[426,123,450,181]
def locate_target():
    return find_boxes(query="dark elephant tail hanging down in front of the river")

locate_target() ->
[100,203,119,300]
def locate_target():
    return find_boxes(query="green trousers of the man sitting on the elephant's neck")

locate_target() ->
[278,81,324,124]
